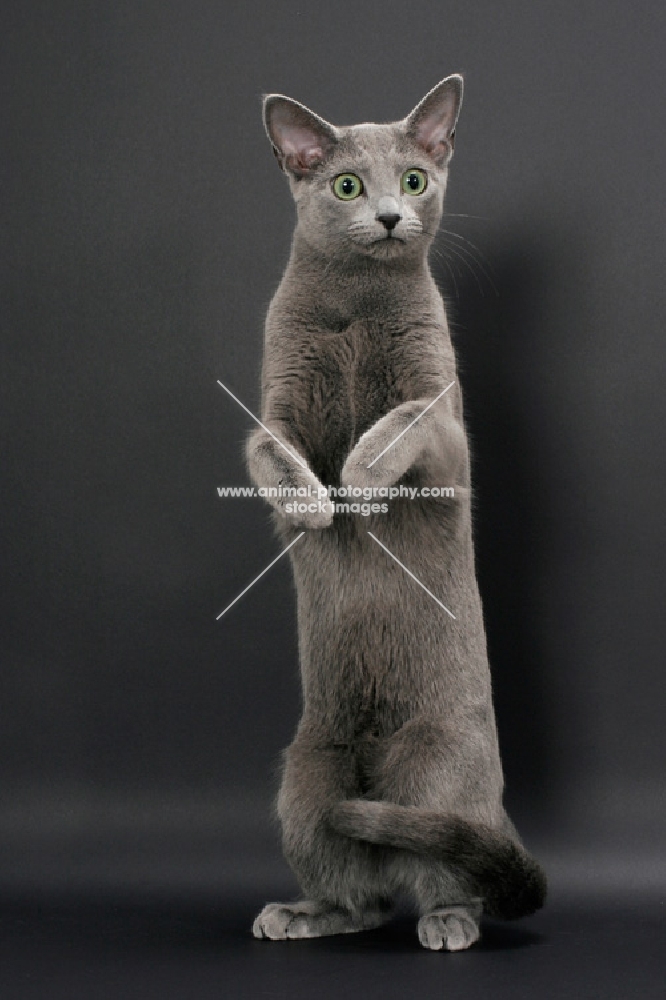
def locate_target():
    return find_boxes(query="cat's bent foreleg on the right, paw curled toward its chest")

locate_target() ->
[341,399,467,487]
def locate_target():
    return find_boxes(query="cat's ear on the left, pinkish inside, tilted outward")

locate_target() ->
[264,94,338,178]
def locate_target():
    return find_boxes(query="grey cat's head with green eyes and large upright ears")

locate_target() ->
[264,74,463,259]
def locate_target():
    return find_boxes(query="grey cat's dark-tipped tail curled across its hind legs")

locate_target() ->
[329,799,546,920]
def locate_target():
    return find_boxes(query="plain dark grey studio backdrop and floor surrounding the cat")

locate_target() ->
[0,0,666,1000]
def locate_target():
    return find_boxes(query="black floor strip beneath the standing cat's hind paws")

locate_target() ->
[0,896,666,1000]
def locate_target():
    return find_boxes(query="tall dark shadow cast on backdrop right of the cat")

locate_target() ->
[432,225,570,827]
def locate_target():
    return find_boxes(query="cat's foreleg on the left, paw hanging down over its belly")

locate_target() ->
[246,428,333,528]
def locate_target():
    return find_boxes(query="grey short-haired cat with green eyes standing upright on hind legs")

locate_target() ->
[247,75,546,951]
